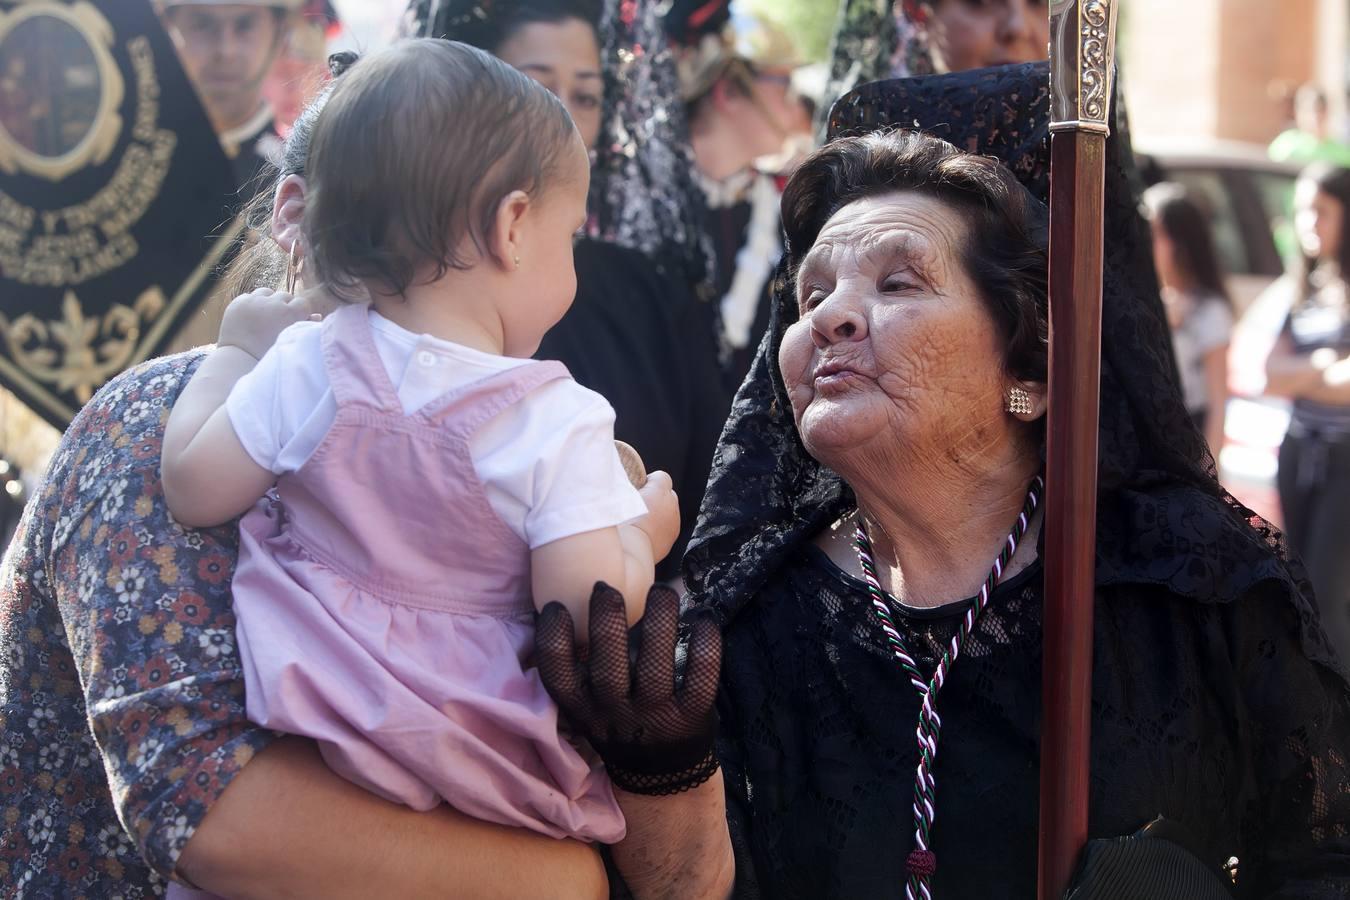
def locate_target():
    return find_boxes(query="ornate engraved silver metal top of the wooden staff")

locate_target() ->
[1050,0,1121,135]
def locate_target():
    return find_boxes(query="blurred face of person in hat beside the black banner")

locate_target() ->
[165,4,282,107]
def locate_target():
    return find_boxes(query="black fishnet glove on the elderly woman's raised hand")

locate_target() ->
[535,583,722,796]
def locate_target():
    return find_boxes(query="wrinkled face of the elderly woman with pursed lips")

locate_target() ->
[779,192,1010,464]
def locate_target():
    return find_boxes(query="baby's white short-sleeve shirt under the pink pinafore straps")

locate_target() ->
[225,309,647,549]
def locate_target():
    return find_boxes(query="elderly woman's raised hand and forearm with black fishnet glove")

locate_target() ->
[535,584,736,900]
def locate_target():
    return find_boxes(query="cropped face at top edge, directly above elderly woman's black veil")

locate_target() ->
[926,0,1050,72]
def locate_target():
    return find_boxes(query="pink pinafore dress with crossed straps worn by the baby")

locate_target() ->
[234,306,624,843]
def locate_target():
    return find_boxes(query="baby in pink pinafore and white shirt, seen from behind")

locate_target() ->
[163,40,679,843]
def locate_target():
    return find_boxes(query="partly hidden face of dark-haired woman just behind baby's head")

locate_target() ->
[495,19,605,150]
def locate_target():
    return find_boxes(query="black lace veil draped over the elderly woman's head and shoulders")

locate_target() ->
[684,62,1337,680]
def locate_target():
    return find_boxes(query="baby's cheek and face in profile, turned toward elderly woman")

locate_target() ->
[500,130,590,359]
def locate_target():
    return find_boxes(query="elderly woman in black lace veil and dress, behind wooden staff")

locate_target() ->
[540,66,1350,899]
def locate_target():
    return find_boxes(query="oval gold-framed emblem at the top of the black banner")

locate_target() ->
[0,0,126,181]
